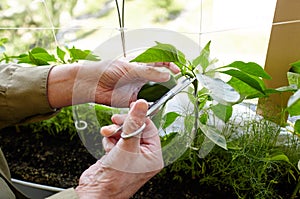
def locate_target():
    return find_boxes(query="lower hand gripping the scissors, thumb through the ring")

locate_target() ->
[76,100,163,199]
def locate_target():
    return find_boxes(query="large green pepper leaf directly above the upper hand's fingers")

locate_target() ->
[130,42,186,67]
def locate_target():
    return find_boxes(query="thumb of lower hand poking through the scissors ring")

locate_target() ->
[118,99,148,152]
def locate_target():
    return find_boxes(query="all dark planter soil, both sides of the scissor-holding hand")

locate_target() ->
[0,128,235,199]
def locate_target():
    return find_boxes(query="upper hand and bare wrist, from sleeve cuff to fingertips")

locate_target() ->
[47,60,180,108]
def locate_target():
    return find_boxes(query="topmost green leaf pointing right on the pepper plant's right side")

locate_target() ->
[223,61,271,79]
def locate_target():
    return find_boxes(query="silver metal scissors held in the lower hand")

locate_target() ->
[111,77,196,139]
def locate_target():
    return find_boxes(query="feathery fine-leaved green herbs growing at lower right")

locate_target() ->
[192,120,300,198]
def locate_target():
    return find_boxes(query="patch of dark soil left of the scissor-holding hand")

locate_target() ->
[0,128,96,188]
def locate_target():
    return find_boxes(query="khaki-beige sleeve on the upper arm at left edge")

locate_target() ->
[0,64,55,129]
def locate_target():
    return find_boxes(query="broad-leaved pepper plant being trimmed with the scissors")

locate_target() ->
[131,42,274,150]
